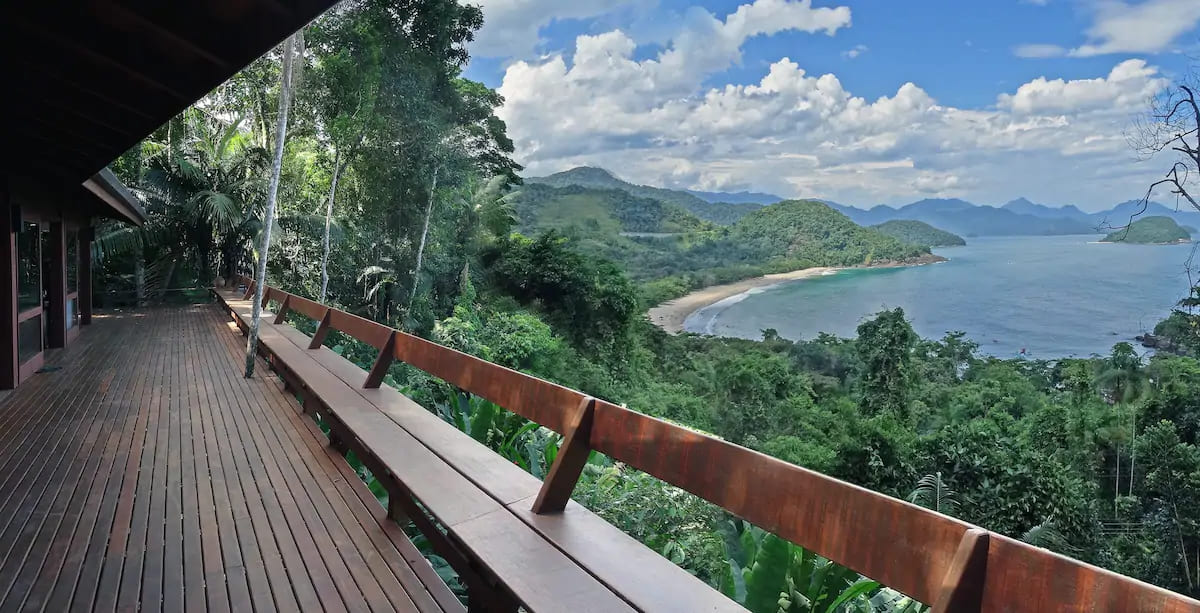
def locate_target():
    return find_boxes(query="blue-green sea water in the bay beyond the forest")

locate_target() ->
[684,235,1200,359]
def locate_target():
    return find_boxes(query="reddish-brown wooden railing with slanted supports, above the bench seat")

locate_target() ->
[226,276,1200,613]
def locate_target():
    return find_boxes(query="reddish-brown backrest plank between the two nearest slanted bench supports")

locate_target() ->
[590,402,970,602]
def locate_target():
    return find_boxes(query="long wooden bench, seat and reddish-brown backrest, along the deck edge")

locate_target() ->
[221,277,1200,613]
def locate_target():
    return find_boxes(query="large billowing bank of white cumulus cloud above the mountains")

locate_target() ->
[499,0,1166,209]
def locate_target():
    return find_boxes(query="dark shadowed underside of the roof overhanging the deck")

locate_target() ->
[0,0,335,185]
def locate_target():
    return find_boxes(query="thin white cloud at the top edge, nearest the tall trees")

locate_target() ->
[470,0,634,58]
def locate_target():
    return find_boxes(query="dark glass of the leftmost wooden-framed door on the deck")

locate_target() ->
[17,221,46,379]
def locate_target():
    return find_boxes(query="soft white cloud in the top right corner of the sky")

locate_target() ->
[1014,0,1200,58]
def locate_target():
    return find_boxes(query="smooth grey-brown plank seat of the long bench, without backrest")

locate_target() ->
[217,290,745,612]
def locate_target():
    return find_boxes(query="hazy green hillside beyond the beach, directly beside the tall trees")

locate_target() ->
[510,184,713,236]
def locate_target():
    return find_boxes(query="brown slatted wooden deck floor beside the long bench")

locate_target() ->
[0,305,461,612]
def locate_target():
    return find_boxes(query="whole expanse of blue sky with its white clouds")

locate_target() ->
[467,0,1200,210]
